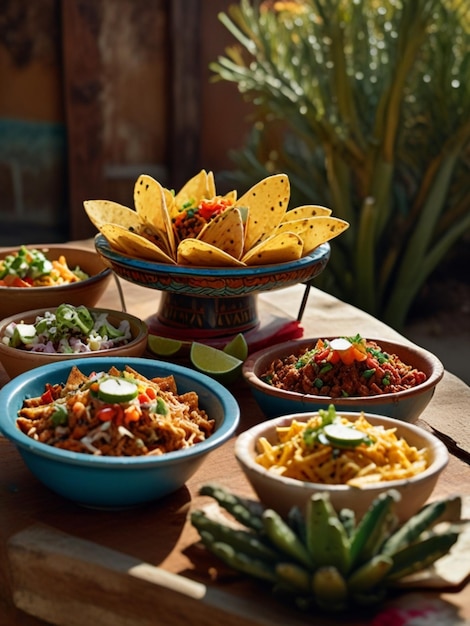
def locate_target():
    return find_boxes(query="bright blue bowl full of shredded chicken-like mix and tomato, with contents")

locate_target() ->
[0,357,239,509]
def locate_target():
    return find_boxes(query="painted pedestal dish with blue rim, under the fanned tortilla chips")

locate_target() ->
[95,235,330,348]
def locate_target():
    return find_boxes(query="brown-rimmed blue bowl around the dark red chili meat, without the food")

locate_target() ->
[243,337,444,422]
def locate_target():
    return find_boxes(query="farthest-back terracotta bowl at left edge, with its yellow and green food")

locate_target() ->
[0,245,112,317]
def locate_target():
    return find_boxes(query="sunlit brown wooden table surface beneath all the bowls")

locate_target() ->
[0,242,470,626]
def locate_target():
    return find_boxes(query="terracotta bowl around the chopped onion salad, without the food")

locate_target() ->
[0,307,148,378]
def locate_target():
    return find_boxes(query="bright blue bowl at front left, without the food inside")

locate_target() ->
[0,357,240,508]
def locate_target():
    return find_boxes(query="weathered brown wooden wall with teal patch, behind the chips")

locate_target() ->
[0,0,250,245]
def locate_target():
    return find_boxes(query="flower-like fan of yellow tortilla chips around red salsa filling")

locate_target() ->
[84,170,349,267]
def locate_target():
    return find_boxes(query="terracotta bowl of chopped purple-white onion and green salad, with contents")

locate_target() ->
[0,303,148,378]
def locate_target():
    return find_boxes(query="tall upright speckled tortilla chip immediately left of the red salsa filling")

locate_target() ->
[134,174,176,257]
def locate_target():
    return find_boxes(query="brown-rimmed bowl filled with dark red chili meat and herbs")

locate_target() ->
[243,335,444,422]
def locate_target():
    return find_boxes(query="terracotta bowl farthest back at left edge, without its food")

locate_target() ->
[0,245,112,317]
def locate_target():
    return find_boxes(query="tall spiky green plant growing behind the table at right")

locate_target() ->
[210,0,470,329]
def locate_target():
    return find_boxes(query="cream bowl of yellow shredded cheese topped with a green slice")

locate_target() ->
[235,405,448,519]
